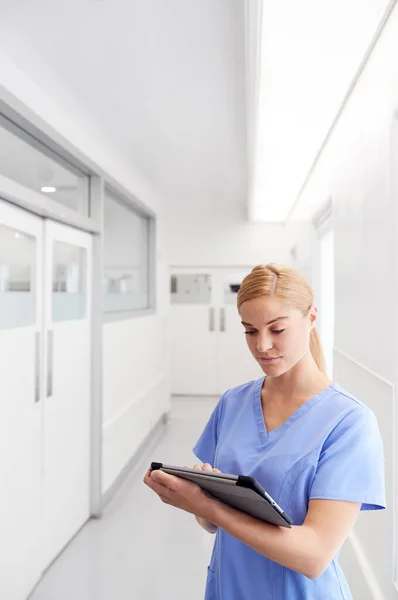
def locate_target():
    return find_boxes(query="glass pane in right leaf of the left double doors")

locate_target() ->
[52,241,87,321]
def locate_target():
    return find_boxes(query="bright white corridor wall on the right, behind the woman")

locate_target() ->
[290,8,398,600]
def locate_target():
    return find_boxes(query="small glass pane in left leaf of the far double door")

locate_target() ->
[171,273,215,304]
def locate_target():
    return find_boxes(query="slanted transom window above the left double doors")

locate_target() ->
[0,116,90,215]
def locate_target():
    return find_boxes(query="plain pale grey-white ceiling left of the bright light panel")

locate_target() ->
[0,0,246,207]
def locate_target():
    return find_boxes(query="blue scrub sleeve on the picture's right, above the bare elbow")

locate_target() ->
[310,406,386,510]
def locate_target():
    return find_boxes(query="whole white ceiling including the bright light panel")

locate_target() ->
[0,0,388,221]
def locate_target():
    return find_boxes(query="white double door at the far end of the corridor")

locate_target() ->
[170,267,261,396]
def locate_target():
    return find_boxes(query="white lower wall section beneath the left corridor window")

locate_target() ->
[103,315,170,492]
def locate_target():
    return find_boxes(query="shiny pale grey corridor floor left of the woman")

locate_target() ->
[31,398,216,600]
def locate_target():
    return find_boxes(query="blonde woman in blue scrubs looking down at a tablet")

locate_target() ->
[144,265,385,600]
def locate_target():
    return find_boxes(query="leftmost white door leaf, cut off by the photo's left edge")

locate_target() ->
[0,200,43,600]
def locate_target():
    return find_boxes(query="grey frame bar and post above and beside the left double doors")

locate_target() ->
[0,175,104,518]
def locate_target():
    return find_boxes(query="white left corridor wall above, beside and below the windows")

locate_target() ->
[0,52,169,491]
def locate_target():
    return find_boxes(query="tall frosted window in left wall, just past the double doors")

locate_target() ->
[103,193,150,313]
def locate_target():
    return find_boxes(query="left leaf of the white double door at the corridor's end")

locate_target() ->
[170,269,217,396]
